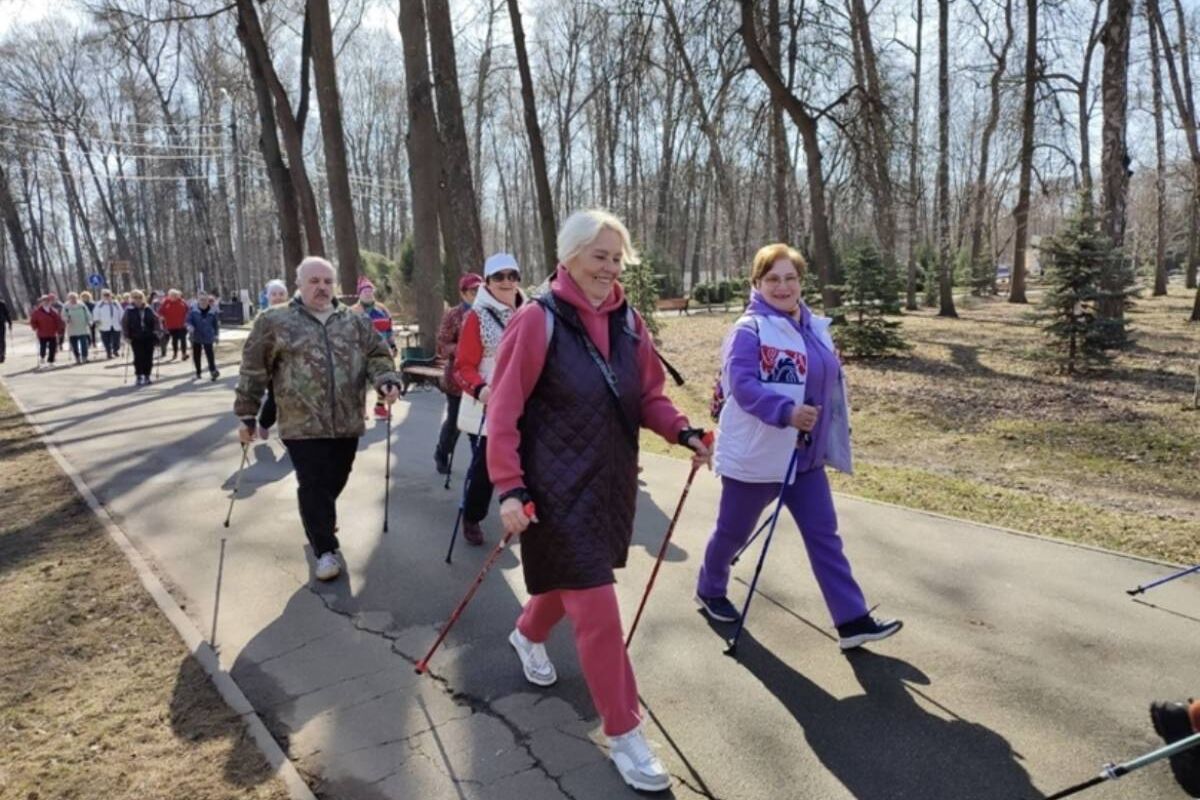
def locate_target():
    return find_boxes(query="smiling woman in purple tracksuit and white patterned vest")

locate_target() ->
[696,243,902,649]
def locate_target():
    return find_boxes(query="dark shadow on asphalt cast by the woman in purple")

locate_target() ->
[738,630,1044,800]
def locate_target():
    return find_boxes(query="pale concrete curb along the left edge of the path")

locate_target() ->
[5,384,317,800]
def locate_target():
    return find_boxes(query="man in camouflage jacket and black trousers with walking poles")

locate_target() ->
[234,258,400,581]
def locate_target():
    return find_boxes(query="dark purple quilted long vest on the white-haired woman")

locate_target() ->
[520,297,642,595]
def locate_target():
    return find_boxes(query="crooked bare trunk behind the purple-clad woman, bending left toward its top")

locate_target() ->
[739,0,840,309]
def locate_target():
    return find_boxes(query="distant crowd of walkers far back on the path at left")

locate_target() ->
[18,289,221,386]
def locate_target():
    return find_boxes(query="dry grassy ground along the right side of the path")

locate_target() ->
[646,287,1200,564]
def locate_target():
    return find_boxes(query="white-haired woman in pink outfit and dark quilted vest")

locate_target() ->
[487,210,710,792]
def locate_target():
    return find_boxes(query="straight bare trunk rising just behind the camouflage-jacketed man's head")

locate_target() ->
[307,0,357,291]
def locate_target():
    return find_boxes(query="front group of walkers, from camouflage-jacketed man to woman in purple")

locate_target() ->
[234,210,901,790]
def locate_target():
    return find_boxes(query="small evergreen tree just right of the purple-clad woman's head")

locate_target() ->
[826,245,908,357]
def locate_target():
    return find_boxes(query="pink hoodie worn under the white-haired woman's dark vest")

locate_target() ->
[487,264,688,494]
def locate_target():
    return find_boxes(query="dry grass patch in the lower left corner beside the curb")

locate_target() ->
[0,383,287,800]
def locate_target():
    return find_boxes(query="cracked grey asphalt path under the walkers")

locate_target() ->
[0,336,1200,800]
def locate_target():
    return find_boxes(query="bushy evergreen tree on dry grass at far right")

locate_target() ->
[1038,209,1132,373]
